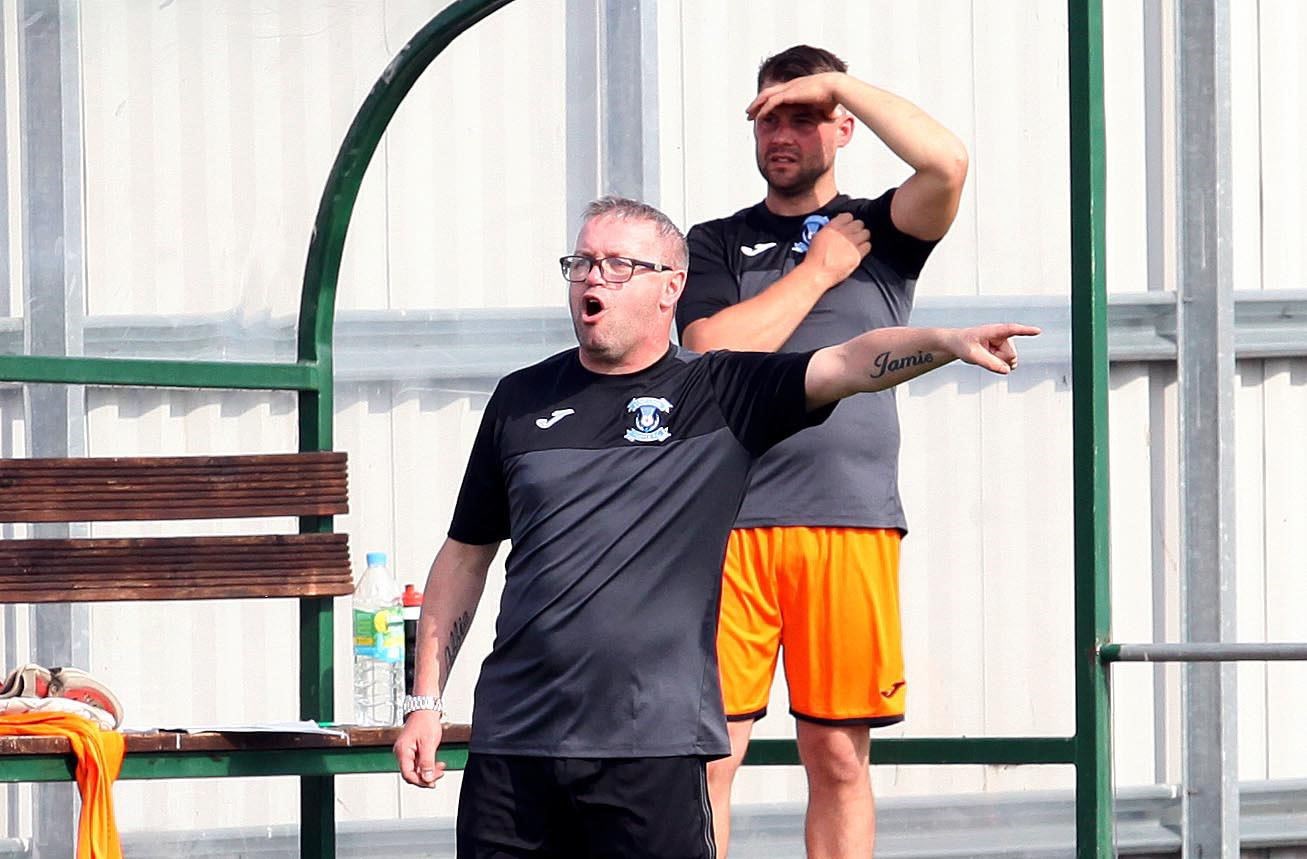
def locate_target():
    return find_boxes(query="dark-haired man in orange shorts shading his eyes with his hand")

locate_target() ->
[677,46,967,859]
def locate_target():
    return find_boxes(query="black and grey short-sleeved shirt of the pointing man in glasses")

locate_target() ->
[450,346,833,757]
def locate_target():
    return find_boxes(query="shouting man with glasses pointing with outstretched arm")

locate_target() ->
[395,197,1038,859]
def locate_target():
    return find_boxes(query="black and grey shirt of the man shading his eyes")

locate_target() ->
[676,190,936,531]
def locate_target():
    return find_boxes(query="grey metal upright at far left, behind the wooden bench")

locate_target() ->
[16,0,90,856]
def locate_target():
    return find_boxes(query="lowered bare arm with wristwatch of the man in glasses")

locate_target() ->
[395,539,499,787]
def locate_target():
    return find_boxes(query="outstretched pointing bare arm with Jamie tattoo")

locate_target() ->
[805,323,1039,409]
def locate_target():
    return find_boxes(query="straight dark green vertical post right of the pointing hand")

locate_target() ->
[1067,0,1112,859]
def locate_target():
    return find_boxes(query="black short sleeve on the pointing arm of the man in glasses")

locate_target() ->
[702,352,835,456]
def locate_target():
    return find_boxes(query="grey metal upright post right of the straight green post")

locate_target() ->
[1175,0,1239,859]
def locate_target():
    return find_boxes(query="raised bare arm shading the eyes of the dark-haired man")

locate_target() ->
[746,72,967,241]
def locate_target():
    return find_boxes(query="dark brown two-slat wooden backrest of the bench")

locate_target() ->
[0,452,353,603]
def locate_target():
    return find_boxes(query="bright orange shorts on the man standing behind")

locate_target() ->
[718,527,907,727]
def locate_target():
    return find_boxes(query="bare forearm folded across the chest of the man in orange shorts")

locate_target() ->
[681,213,872,352]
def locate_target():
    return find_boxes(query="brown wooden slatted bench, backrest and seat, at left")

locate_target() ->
[0,452,418,781]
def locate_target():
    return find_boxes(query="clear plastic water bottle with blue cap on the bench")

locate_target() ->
[354,552,404,726]
